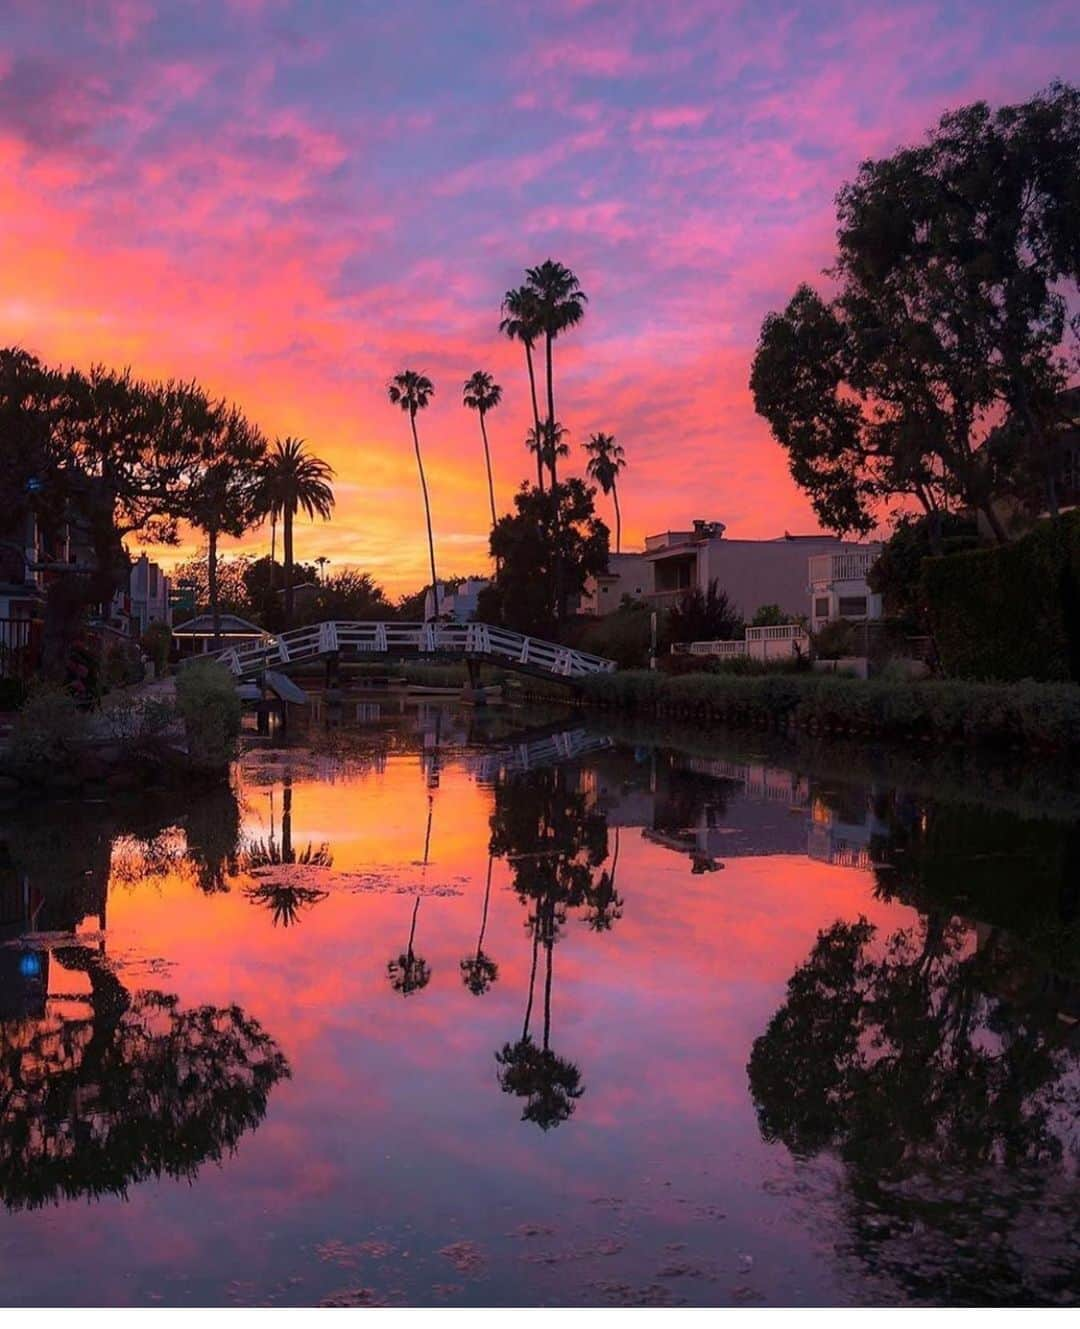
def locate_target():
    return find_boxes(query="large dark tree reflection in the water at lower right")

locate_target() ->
[748,914,1080,1304]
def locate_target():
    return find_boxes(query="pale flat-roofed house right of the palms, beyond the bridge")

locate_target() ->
[583,521,867,619]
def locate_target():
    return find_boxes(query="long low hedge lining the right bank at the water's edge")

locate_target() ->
[579,670,1080,748]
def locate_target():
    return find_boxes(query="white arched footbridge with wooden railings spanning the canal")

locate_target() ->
[219,622,615,679]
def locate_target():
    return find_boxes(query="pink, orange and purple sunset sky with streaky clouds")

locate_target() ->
[0,0,1080,594]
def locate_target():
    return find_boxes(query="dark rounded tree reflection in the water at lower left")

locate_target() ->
[0,946,290,1209]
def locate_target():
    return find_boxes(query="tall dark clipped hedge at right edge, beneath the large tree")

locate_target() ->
[922,512,1080,682]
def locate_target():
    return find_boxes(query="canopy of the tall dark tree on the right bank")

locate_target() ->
[751,84,1080,540]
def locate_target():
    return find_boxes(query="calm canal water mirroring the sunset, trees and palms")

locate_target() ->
[0,696,1080,1306]
